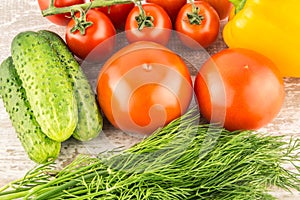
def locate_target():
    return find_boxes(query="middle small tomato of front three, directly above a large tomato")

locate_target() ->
[125,3,172,45]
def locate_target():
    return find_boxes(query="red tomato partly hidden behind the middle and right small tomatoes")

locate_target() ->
[146,0,186,23]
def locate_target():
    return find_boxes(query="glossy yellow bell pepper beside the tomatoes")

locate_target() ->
[223,0,300,77]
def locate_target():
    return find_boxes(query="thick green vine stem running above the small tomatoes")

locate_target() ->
[42,0,132,17]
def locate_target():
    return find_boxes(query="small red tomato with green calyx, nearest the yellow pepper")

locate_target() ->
[175,1,220,49]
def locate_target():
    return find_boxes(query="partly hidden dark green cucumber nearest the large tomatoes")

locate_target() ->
[38,30,103,141]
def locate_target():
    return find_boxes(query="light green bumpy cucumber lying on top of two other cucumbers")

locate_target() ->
[11,31,78,142]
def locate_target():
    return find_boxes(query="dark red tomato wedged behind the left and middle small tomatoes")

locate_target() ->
[91,3,134,30]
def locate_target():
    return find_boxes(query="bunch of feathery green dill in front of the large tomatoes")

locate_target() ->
[0,109,300,200]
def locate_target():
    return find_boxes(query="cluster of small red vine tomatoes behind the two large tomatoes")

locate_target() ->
[38,0,231,61]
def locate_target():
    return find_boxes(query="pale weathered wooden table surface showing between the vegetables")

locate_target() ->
[0,0,300,199]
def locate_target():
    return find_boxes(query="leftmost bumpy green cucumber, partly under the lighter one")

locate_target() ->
[0,57,61,163]
